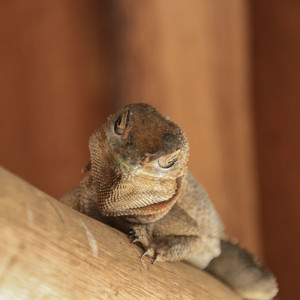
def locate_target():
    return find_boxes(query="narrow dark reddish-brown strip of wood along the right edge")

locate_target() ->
[253,0,300,299]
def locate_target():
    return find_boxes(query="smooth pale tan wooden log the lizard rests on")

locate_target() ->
[0,168,240,300]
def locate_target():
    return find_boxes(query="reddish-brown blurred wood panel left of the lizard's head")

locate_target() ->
[0,0,110,196]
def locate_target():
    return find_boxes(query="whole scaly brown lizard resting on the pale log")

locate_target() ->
[60,103,278,300]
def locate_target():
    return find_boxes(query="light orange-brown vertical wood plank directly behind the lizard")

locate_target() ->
[114,0,261,254]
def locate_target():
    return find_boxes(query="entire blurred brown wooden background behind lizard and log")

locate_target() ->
[0,0,300,300]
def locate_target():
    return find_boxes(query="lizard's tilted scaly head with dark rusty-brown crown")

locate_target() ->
[89,104,188,221]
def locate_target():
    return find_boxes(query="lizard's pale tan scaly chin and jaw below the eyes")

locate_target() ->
[93,166,183,220]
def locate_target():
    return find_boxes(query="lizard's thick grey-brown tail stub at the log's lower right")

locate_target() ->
[205,240,278,300]
